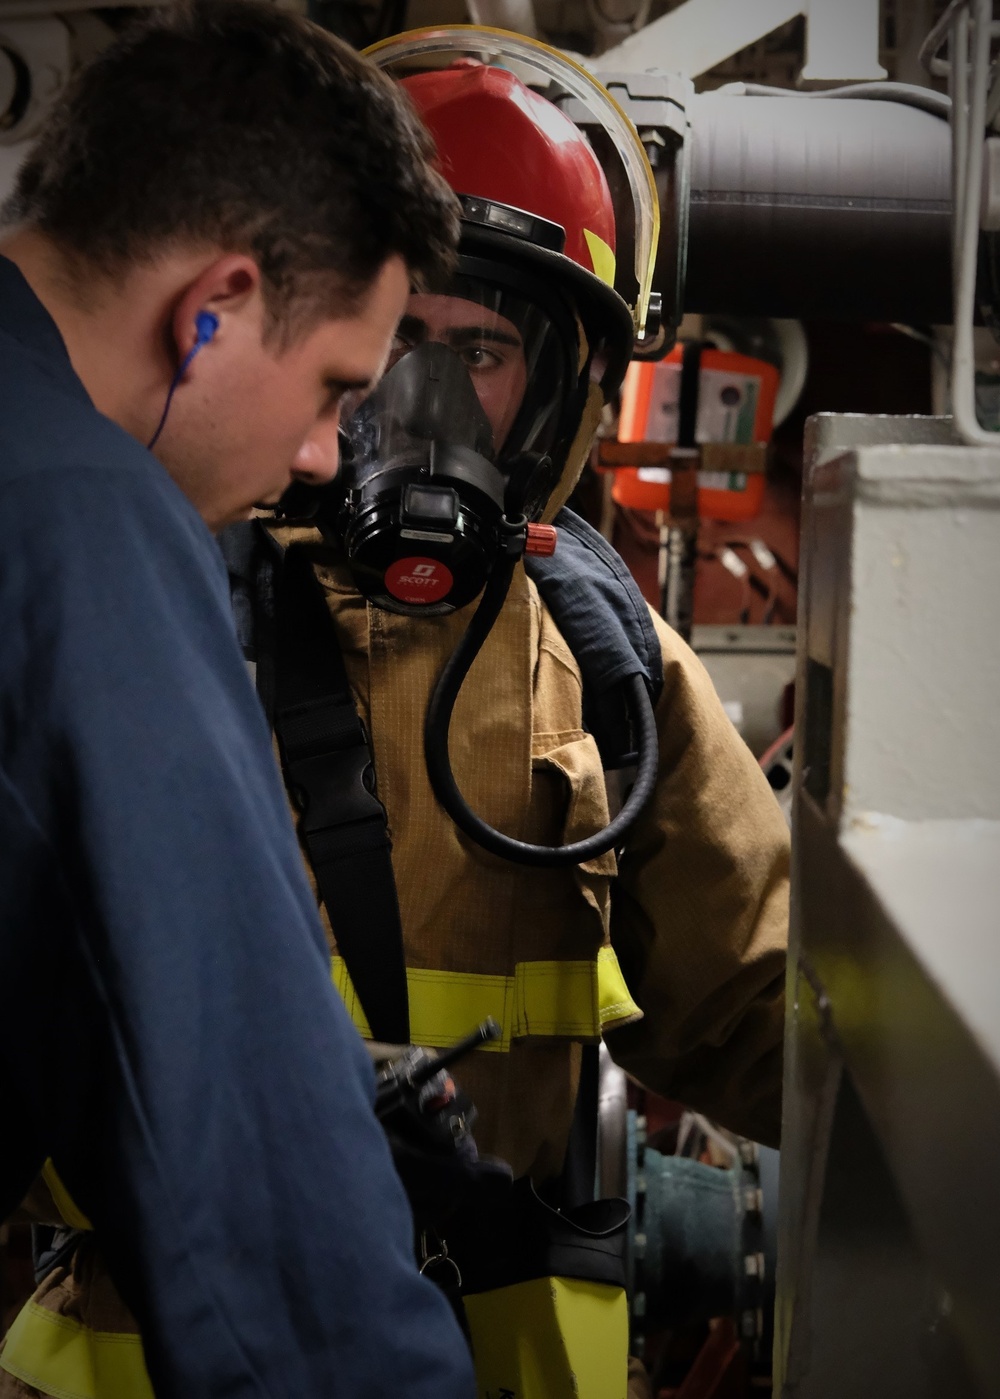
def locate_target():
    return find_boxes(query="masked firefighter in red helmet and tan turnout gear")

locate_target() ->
[0,27,789,1399]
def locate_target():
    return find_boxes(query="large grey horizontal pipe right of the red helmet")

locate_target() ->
[679,92,951,323]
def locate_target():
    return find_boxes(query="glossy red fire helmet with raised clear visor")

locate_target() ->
[366,25,660,341]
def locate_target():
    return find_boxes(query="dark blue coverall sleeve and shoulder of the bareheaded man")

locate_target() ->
[0,467,474,1399]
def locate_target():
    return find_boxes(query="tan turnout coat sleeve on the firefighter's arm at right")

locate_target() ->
[607,616,789,1144]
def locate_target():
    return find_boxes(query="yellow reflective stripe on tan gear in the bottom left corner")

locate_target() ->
[0,1302,154,1399]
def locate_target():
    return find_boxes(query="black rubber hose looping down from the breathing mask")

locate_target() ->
[424,545,659,869]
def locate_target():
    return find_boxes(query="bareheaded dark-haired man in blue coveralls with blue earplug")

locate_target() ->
[0,0,471,1399]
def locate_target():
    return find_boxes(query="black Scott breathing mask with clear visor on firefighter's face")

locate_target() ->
[317,256,587,617]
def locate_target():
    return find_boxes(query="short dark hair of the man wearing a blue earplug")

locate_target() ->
[4,0,457,327]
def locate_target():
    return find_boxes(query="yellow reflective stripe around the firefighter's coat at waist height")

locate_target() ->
[331,947,641,1053]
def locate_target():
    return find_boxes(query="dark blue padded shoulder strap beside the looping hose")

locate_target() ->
[524,509,663,768]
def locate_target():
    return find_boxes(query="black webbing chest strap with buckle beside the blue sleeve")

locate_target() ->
[274,546,410,1044]
